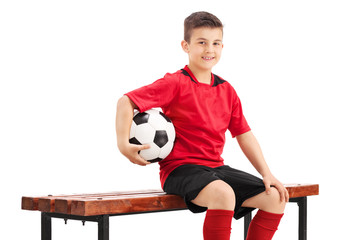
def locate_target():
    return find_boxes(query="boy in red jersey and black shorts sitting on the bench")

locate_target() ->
[116,12,289,240]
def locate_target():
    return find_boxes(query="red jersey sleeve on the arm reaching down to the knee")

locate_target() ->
[228,90,251,137]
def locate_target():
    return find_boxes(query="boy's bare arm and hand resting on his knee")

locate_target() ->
[236,131,289,202]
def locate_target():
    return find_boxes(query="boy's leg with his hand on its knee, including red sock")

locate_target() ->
[242,188,286,240]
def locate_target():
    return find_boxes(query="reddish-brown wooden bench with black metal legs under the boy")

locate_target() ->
[22,184,319,240]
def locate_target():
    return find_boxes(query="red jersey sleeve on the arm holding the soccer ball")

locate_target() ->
[125,74,178,112]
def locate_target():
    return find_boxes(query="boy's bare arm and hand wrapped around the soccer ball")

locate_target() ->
[116,95,150,166]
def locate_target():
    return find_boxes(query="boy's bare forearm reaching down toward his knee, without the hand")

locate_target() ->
[236,131,271,177]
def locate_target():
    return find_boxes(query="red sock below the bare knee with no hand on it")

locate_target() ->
[204,209,234,240]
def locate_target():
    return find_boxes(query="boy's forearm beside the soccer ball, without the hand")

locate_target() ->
[116,95,136,152]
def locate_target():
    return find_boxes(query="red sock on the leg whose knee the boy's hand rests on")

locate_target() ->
[246,210,284,240]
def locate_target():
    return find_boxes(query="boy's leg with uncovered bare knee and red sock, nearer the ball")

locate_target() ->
[192,180,235,240]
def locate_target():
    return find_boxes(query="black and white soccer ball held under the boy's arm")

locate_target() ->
[129,109,175,163]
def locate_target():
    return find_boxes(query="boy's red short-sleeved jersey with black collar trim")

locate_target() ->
[126,66,250,186]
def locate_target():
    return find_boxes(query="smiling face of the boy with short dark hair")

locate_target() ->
[181,27,224,71]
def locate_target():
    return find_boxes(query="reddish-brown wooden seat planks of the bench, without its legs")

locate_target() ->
[22,184,319,216]
